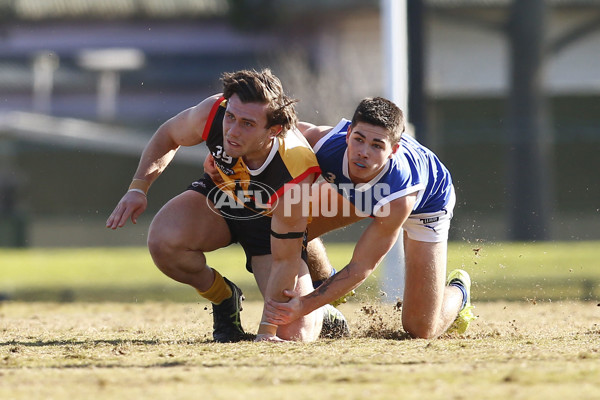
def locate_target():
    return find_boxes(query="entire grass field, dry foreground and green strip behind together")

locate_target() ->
[0,242,600,400]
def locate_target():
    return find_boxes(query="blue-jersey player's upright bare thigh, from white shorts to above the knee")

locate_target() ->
[402,234,448,317]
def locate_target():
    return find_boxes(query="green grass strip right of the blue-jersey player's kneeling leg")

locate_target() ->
[448,242,600,301]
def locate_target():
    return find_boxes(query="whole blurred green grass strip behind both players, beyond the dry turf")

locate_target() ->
[0,242,600,302]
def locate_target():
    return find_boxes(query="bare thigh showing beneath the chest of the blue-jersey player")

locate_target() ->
[308,182,366,241]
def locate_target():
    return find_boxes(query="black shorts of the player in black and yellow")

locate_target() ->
[187,174,307,272]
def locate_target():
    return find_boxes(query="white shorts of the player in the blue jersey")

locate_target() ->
[402,186,456,243]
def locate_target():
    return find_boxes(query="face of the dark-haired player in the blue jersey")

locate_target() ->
[346,122,399,183]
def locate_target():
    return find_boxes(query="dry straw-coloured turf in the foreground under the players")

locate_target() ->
[0,302,600,400]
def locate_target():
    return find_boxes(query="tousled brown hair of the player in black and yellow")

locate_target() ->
[221,68,298,135]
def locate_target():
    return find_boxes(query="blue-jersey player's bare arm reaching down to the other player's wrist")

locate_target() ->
[266,193,416,324]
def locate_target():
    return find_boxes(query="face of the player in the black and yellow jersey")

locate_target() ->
[223,94,281,168]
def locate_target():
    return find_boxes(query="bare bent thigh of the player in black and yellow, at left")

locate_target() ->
[148,190,231,251]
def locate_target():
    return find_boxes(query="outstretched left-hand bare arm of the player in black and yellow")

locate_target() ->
[106,95,219,229]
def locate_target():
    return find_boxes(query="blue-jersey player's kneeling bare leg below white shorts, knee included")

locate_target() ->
[402,233,463,339]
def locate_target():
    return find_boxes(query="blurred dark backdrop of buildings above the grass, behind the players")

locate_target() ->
[0,0,600,247]
